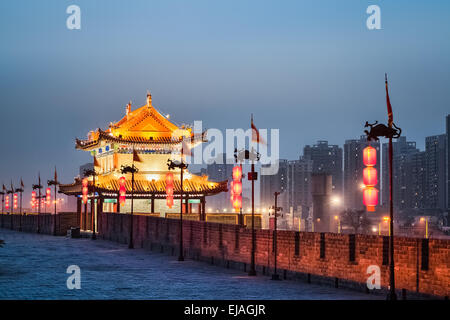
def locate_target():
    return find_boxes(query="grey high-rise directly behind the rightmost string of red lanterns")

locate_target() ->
[344,135,381,209]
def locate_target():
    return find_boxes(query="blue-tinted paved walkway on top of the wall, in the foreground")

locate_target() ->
[0,229,383,299]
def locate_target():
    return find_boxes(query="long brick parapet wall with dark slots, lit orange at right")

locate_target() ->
[0,213,450,297]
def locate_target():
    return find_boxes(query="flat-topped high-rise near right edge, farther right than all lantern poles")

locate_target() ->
[425,134,447,211]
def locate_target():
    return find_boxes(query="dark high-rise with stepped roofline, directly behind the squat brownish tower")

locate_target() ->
[303,141,343,196]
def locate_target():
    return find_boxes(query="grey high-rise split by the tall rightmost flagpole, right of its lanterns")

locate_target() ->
[381,136,419,210]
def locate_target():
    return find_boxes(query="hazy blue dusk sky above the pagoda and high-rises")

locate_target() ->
[0,0,450,191]
